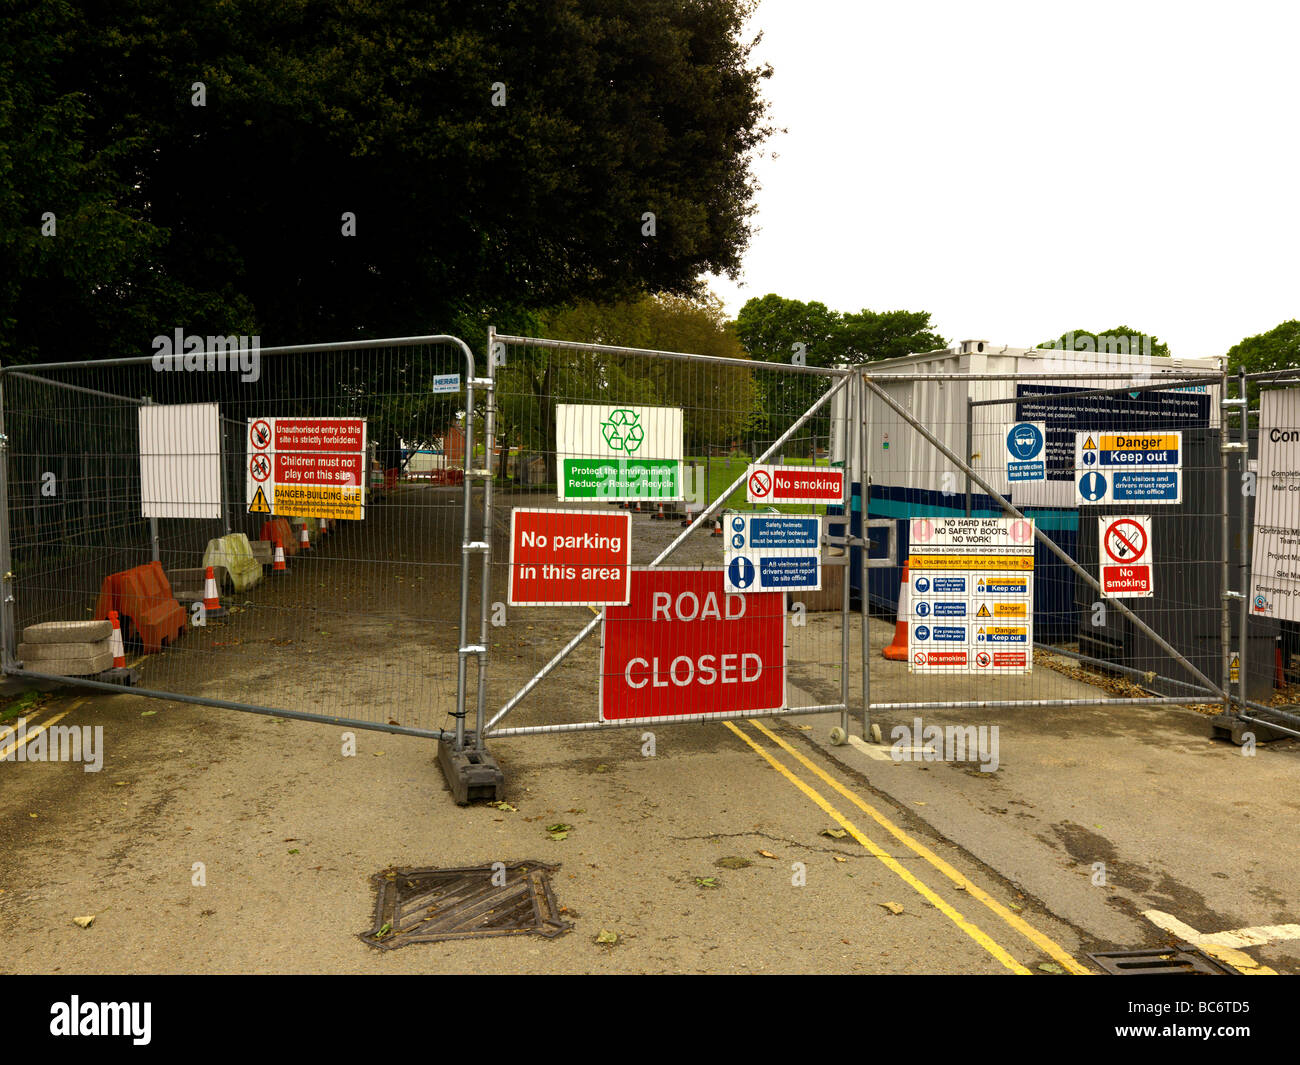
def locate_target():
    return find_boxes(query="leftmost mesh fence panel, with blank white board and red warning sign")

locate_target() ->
[0,338,469,735]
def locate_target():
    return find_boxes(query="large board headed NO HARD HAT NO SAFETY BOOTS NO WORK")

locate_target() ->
[906,518,1034,674]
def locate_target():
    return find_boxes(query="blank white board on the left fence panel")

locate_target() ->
[139,403,221,518]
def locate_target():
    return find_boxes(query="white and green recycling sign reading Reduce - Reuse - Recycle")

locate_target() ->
[555,403,685,502]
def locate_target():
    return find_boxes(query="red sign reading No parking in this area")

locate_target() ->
[510,508,632,606]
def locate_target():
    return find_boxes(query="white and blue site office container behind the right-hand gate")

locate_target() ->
[829,341,1221,640]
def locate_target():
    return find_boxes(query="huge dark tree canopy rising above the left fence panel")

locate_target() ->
[0,0,771,360]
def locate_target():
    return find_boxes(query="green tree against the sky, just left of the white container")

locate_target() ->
[736,293,945,440]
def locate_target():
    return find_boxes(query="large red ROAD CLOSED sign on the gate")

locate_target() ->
[601,570,785,722]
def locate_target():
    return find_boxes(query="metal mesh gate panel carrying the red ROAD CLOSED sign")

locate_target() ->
[488,338,848,735]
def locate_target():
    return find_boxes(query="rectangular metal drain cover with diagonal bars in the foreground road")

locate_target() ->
[360,861,573,951]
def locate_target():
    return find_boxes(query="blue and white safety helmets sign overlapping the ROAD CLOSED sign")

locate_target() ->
[723,514,822,593]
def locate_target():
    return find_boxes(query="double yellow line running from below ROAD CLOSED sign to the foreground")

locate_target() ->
[723,720,1091,977]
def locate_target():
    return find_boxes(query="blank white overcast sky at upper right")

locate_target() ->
[712,0,1300,355]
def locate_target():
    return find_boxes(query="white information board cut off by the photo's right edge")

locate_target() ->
[1243,389,1300,622]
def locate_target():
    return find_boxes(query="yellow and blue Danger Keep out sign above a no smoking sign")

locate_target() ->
[1074,430,1183,506]
